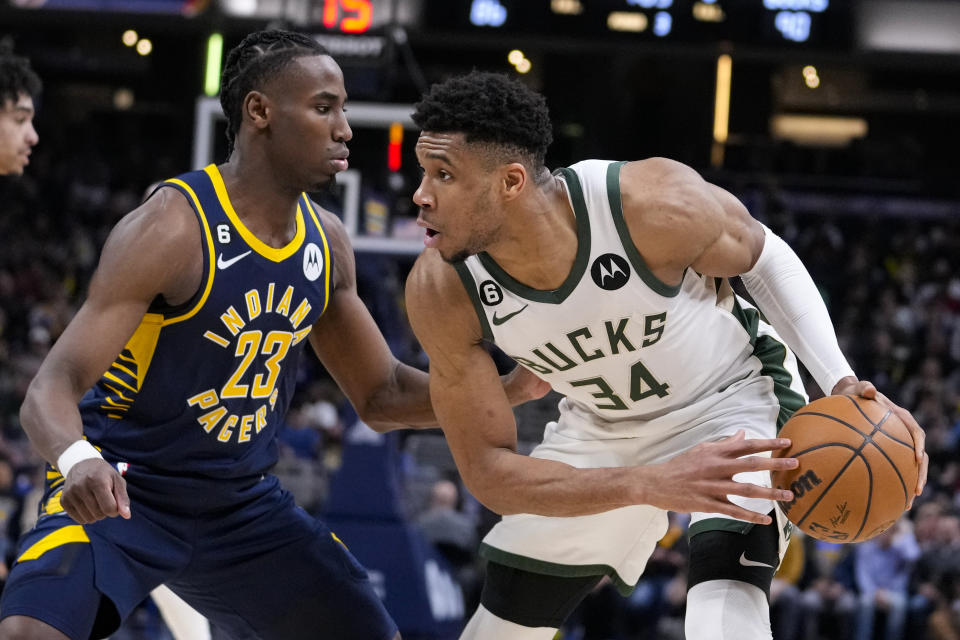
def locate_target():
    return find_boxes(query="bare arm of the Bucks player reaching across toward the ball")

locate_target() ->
[407,250,796,524]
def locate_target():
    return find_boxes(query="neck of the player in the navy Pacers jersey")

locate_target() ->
[219,159,300,248]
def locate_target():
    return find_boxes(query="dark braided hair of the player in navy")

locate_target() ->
[220,29,330,149]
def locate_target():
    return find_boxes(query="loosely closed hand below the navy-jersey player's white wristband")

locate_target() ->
[60,458,130,524]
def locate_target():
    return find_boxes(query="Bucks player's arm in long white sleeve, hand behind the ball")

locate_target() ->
[621,158,927,495]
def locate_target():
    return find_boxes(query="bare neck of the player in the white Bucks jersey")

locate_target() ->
[487,177,579,291]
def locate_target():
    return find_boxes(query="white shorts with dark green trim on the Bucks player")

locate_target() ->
[480,364,806,594]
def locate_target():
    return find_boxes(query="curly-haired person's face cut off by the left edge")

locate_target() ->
[0,47,41,176]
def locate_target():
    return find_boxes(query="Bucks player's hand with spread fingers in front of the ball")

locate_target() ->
[647,430,799,524]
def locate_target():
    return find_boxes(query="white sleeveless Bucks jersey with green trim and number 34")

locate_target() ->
[456,160,804,422]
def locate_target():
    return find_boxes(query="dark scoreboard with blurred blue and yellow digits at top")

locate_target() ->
[422,0,853,49]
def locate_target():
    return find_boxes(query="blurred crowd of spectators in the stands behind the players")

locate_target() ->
[0,131,960,640]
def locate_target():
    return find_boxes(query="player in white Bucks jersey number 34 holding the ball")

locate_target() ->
[407,72,926,640]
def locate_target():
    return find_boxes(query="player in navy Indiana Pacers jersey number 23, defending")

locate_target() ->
[0,31,542,640]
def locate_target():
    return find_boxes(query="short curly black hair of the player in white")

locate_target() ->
[413,71,553,169]
